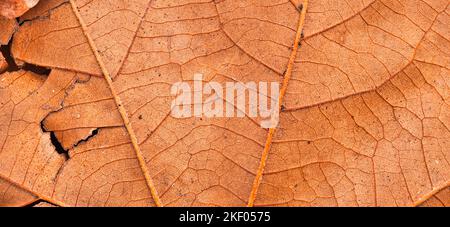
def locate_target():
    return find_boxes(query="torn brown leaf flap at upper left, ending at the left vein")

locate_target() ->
[12,4,101,75]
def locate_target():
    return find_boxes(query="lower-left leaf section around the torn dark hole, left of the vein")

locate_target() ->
[0,70,155,206]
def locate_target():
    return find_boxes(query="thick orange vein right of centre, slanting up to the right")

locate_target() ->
[247,0,308,207]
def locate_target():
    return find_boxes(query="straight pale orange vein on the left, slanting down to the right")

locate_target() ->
[70,0,162,207]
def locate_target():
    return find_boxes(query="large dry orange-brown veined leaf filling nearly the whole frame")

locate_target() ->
[0,0,450,206]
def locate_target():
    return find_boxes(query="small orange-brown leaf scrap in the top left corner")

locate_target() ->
[0,0,39,19]
